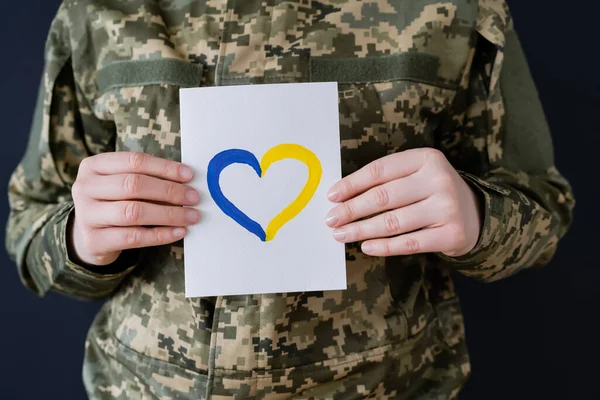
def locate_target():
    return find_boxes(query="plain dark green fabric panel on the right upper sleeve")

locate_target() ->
[500,31,554,173]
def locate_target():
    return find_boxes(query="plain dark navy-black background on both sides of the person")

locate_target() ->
[0,0,600,400]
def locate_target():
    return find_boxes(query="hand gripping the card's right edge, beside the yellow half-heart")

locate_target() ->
[325,148,481,257]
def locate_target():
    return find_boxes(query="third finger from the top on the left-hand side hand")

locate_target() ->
[87,201,200,227]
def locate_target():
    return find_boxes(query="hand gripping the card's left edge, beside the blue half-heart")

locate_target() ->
[67,152,200,265]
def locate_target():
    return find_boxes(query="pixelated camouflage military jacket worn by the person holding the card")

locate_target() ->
[6,0,574,399]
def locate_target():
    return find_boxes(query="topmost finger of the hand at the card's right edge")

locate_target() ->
[327,149,425,202]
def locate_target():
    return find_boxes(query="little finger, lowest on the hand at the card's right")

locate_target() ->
[361,227,447,257]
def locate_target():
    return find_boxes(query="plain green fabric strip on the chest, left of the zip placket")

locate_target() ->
[97,58,203,92]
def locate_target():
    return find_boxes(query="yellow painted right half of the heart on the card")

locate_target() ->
[260,144,323,242]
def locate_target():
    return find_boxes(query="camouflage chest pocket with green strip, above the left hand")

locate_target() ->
[94,59,203,161]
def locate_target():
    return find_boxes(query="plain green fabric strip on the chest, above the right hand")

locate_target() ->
[310,53,440,84]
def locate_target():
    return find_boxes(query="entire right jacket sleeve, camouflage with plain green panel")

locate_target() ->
[439,0,574,281]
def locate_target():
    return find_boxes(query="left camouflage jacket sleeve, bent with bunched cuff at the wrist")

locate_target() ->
[6,7,134,299]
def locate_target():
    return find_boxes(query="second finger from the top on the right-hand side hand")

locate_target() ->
[325,175,431,228]
